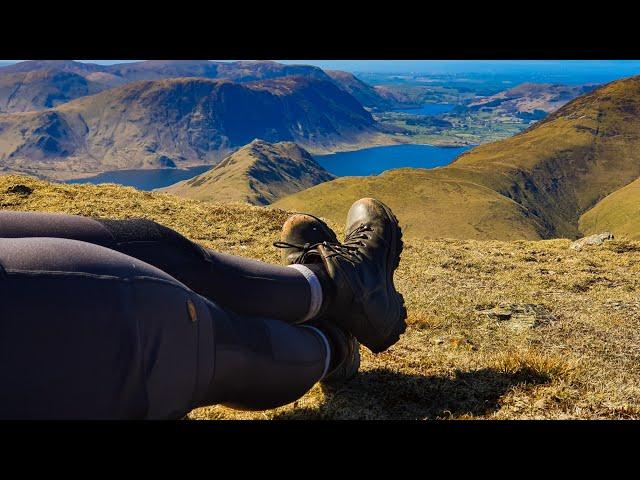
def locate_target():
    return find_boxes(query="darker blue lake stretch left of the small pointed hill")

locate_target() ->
[66,165,211,190]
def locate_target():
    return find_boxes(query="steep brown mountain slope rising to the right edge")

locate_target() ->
[452,77,640,237]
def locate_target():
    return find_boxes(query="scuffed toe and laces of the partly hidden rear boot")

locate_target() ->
[273,213,338,265]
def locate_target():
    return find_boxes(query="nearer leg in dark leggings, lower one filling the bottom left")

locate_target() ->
[0,238,340,418]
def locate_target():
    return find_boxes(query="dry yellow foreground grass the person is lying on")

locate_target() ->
[0,176,640,419]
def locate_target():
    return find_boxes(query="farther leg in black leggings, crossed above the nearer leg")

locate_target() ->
[0,211,322,323]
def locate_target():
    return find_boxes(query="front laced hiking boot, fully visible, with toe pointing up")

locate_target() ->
[316,198,407,353]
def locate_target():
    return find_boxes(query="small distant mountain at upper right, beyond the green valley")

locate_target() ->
[467,83,596,120]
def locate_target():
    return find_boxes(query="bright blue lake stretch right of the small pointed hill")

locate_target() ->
[314,145,470,177]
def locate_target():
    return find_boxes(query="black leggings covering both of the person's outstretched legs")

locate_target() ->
[0,212,328,418]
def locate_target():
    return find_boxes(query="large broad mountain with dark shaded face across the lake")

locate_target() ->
[0,77,381,178]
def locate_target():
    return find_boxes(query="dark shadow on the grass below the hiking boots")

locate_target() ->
[275,368,550,420]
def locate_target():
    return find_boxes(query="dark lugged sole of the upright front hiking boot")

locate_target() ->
[370,202,407,353]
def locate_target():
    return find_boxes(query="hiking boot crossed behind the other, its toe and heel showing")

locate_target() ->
[274,213,360,387]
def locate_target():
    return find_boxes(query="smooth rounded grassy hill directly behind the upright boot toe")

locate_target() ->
[273,168,543,240]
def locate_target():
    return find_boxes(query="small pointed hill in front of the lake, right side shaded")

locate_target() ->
[163,139,335,205]
